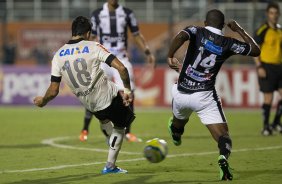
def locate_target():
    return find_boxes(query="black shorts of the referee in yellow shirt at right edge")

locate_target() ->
[258,62,282,93]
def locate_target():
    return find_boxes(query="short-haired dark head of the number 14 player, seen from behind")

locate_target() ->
[206,9,225,29]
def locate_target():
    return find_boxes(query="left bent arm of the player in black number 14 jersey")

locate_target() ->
[167,31,189,72]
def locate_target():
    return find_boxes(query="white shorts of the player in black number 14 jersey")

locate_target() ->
[172,84,226,125]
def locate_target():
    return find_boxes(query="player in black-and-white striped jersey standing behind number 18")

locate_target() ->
[80,0,155,142]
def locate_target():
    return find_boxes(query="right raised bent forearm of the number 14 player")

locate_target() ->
[227,20,260,57]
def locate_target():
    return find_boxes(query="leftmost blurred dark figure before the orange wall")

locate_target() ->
[3,35,17,65]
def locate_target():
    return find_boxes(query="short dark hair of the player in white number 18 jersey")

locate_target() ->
[71,16,92,36]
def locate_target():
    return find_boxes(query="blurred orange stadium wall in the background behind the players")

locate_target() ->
[0,20,242,66]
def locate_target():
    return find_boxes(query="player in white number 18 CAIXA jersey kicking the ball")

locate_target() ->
[34,16,135,174]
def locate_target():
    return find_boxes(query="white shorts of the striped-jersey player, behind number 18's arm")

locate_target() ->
[101,57,135,90]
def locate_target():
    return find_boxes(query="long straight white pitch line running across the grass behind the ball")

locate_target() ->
[0,137,282,174]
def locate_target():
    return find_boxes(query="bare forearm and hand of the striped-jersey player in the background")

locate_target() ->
[134,33,156,67]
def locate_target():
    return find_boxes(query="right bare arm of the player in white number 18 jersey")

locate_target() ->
[111,58,133,106]
